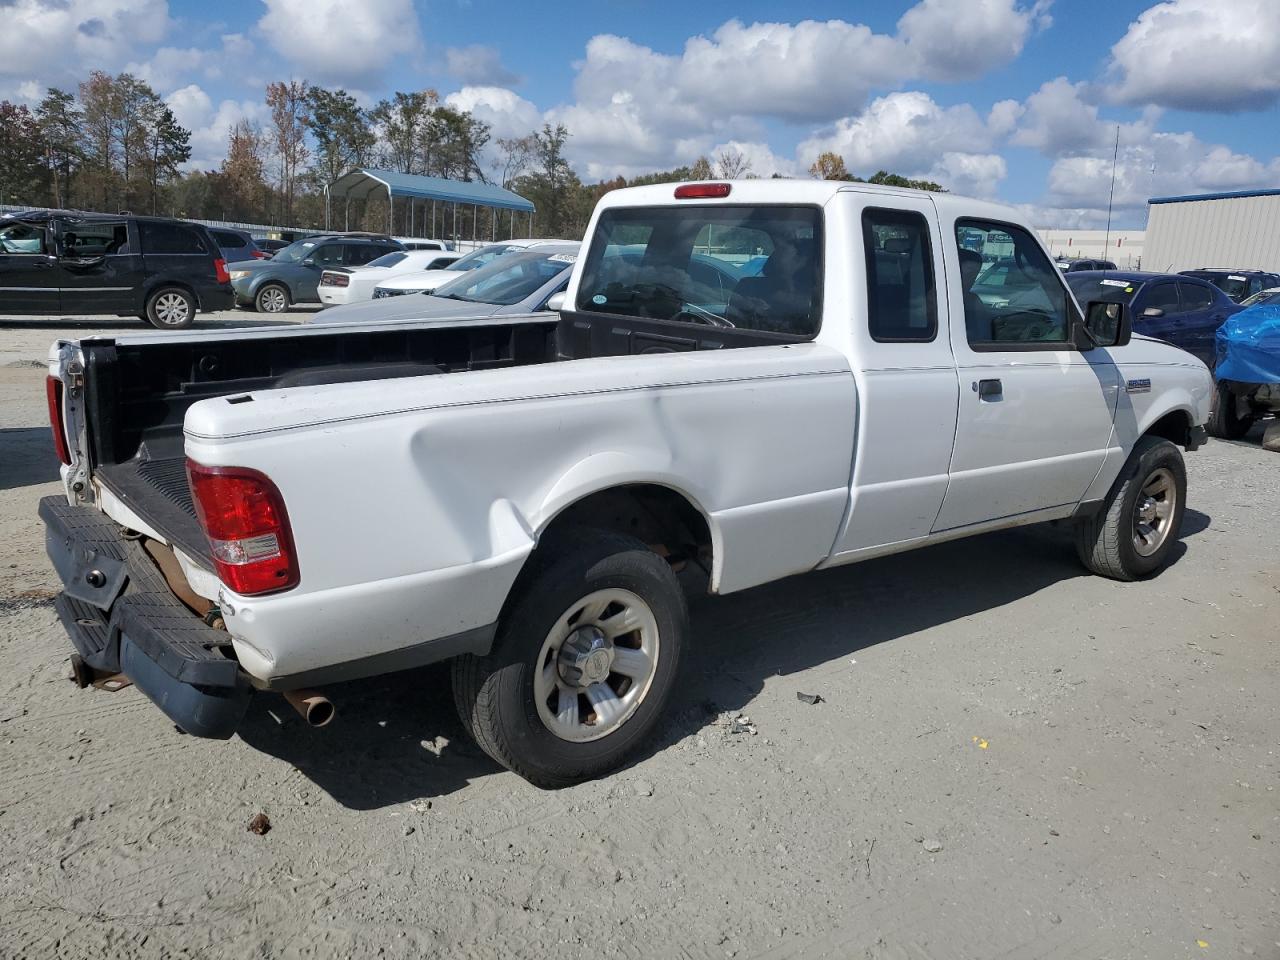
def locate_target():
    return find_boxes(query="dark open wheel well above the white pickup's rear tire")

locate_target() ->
[541,484,713,572]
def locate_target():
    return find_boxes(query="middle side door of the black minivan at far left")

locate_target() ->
[58,218,142,314]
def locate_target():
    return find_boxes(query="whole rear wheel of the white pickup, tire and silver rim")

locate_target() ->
[453,531,689,788]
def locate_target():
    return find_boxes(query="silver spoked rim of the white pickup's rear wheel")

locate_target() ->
[534,588,660,744]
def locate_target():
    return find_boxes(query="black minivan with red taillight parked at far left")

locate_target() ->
[0,212,233,330]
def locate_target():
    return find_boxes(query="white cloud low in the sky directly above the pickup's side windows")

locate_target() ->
[796,91,1009,195]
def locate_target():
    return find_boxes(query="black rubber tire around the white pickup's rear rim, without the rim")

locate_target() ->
[453,530,689,790]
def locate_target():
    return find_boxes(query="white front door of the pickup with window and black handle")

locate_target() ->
[933,219,1119,532]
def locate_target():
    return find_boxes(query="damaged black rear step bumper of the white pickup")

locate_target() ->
[40,497,253,739]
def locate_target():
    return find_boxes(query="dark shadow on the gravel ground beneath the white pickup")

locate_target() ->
[239,509,1211,810]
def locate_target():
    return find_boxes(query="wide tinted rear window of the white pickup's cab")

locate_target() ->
[576,205,822,339]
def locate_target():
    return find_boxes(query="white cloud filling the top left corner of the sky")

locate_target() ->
[0,0,169,83]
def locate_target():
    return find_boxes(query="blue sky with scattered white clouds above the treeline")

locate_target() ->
[0,0,1280,228]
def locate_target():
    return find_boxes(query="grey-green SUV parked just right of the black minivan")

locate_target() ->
[229,233,403,314]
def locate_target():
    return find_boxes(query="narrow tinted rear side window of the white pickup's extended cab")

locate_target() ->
[863,209,938,343]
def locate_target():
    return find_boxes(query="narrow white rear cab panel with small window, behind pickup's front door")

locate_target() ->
[826,192,957,562]
